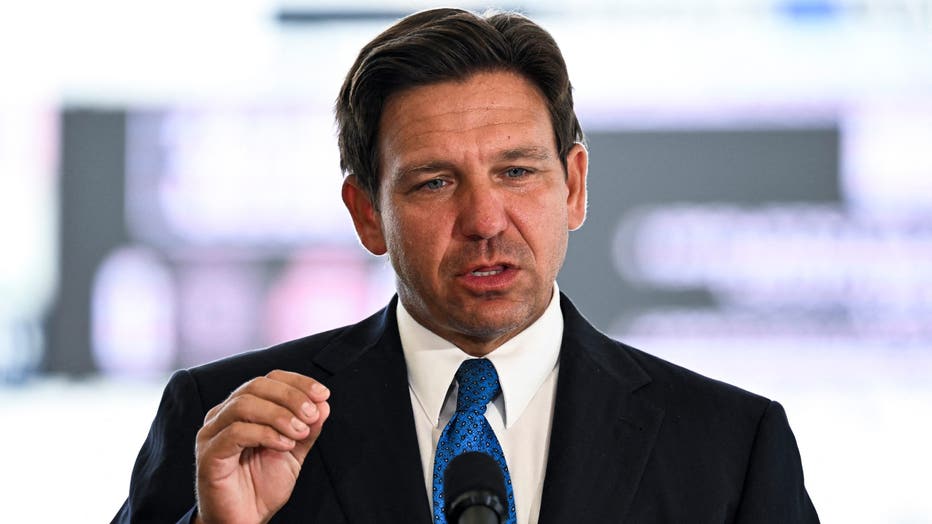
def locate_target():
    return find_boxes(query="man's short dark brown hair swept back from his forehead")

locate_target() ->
[336,9,583,202]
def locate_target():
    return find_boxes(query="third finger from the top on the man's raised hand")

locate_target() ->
[201,393,319,440]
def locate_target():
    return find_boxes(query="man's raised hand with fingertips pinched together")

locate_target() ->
[196,370,330,524]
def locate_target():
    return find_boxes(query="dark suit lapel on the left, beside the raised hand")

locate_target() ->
[315,299,430,523]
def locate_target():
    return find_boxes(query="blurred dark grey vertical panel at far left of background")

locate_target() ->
[43,109,128,375]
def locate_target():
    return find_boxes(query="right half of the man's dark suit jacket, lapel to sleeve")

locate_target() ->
[540,297,818,524]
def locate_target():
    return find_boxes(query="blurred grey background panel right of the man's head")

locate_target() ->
[560,128,841,330]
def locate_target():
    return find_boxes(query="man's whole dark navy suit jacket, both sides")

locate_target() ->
[114,296,818,524]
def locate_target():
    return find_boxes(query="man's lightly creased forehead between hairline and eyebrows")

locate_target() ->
[378,71,556,172]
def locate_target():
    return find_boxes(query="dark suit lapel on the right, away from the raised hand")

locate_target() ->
[539,296,663,524]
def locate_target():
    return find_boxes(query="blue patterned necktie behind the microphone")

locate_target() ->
[434,358,517,524]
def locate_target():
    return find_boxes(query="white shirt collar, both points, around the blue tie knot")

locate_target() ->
[396,282,563,428]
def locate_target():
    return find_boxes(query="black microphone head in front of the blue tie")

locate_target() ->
[443,451,508,524]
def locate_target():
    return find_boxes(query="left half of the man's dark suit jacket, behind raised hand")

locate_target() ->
[114,300,430,524]
